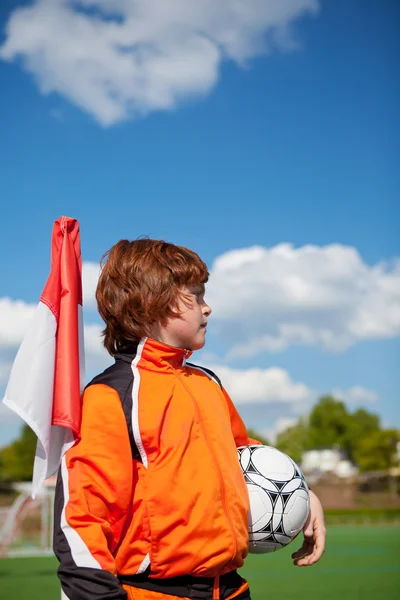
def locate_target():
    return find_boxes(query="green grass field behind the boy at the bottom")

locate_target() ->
[0,526,400,600]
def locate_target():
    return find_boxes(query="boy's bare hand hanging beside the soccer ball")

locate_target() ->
[292,490,326,567]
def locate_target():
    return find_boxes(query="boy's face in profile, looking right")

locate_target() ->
[151,283,211,350]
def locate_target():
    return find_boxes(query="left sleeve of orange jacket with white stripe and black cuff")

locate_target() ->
[54,384,132,600]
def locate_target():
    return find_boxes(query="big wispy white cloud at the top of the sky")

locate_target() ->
[0,0,319,125]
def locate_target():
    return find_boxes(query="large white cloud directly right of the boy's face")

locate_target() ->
[207,244,400,358]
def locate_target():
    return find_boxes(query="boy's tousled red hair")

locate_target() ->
[96,239,208,355]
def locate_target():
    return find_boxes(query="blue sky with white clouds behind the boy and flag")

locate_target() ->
[0,0,400,445]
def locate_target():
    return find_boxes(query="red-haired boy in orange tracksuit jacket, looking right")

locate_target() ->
[54,239,324,600]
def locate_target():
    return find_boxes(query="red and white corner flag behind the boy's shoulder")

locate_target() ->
[3,217,84,498]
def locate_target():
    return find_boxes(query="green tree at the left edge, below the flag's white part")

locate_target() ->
[0,425,37,481]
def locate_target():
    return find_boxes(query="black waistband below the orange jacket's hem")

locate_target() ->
[118,571,249,600]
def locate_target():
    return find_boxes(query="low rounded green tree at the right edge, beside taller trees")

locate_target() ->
[354,429,400,472]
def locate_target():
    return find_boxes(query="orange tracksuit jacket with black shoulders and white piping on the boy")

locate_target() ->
[54,338,260,600]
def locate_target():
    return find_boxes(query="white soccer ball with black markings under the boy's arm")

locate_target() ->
[238,445,310,554]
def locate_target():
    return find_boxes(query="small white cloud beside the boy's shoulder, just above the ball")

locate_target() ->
[205,365,314,405]
